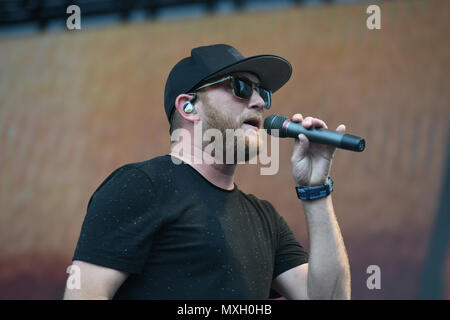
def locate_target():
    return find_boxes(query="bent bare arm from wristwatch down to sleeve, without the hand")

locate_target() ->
[273,196,351,300]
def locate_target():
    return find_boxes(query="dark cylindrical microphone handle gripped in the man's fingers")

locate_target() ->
[281,120,366,152]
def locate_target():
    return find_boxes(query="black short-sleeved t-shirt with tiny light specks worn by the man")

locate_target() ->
[73,155,308,299]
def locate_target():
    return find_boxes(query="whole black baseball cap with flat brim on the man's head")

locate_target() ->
[164,44,292,120]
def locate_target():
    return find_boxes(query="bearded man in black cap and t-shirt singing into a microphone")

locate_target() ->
[64,45,350,299]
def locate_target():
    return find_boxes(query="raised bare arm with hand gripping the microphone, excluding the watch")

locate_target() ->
[273,114,350,299]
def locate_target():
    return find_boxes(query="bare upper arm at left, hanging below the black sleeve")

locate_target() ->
[64,260,128,300]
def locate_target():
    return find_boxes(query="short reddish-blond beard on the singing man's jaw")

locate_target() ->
[202,99,263,164]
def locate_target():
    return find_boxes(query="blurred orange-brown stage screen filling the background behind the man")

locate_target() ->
[0,0,450,299]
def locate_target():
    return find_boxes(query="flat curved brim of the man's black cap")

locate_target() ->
[197,55,292,92]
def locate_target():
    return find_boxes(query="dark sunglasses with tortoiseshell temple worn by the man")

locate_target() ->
[195,76,272,109]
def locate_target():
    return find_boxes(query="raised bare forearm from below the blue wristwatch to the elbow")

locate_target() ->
[303,196,350,299]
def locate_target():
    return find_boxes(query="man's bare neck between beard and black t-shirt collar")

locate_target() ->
[170,142,236,190]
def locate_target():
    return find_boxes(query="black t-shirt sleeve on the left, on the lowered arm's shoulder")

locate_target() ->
[73,166,162,273]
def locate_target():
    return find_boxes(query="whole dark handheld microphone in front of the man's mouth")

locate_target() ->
[264,114,366,152]
